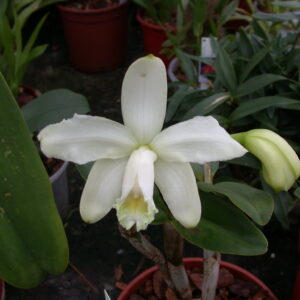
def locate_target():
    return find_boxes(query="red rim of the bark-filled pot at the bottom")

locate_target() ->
[117,257,278,300]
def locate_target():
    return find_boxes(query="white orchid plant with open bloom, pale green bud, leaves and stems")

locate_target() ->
[38,55,300,300]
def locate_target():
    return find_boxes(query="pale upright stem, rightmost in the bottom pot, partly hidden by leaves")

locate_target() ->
[202,163,221,300]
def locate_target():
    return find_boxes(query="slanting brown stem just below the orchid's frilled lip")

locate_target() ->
[119,225,174,289]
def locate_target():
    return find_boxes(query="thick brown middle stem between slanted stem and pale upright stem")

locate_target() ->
[164,222,192,300]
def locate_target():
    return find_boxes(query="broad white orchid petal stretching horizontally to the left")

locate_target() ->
[38,115,137,164]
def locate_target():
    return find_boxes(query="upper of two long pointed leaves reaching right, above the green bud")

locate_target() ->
[237,74,288,97]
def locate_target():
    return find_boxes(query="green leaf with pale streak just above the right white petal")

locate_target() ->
[182,93,229,120]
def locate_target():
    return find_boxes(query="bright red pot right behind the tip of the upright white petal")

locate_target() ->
[137,11,175,66]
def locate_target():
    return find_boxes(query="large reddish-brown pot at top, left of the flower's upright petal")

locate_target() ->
[58,2,129,72]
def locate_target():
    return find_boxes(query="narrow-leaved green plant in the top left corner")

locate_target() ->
[0,0,62,96]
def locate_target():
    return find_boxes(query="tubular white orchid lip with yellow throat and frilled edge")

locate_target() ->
[115,147,157,231]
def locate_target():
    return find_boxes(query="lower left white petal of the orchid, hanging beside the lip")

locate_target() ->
[79,159,127,223]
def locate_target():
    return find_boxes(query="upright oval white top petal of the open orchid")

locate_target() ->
[121,55,167,144]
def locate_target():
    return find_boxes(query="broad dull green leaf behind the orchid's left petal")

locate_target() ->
[22,89,90,132]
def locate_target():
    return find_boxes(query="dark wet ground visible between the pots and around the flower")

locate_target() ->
[6,6,299,300]
